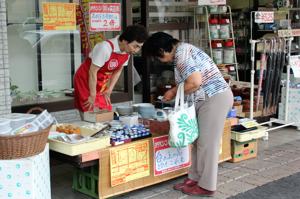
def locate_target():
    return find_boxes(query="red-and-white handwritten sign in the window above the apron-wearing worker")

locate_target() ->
[89,3,121,31]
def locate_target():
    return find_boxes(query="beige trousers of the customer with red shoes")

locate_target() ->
[188,89,233,191]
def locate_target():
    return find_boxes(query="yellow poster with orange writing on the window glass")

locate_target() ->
[43,3,76,30]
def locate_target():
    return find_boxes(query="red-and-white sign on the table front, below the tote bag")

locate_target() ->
[153,135,191,176]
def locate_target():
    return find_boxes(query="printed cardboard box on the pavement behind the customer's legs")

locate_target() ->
[230,140,257,162]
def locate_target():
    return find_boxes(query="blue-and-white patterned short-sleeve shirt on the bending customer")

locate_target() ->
[174,43,229,102]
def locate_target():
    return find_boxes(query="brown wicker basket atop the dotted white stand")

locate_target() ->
[0,126,51,160]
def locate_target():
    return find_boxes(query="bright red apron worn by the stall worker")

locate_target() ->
[74,40,129,112]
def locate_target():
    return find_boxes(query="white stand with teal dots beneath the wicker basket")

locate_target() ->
[0,144,51,199]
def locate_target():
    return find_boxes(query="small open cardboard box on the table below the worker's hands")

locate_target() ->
[83,111,114,122]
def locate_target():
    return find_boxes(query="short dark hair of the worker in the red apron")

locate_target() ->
[119,24,148,43]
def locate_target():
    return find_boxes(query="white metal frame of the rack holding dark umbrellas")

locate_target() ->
[250,11,300,133]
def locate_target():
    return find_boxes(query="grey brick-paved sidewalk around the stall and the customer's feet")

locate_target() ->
[51,127,300,199]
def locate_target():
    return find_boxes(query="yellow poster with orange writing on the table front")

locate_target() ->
[110,140,150,187]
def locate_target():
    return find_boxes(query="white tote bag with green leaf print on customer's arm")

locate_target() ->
[168,83,199,148]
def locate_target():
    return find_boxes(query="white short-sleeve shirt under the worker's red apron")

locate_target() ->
[89,36,129,68]
